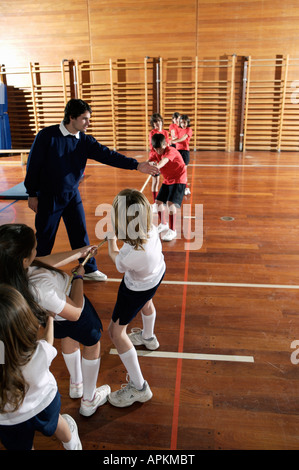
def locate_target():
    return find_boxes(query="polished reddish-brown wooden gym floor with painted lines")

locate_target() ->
[0,151,299,453]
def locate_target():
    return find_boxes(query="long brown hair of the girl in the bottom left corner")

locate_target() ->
[0,284,39,413]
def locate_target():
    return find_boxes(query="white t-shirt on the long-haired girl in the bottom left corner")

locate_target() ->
[0,340,58,425]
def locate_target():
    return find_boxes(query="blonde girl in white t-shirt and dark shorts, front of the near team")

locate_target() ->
[108,189,165,407]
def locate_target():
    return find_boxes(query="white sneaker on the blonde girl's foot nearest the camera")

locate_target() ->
[108,381,153,408]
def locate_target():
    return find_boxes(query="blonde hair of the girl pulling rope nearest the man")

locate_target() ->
[111,189,152,250]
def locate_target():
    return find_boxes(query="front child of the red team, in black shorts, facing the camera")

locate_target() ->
[150,134,187,241]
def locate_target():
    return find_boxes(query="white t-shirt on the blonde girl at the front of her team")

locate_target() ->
[115,226,165,291]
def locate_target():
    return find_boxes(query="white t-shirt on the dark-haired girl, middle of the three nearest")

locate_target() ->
[28,266,71,320]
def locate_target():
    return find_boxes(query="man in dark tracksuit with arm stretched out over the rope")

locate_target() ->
[24,99,158,281]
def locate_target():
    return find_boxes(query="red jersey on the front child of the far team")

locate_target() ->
[149,147,187,184]
